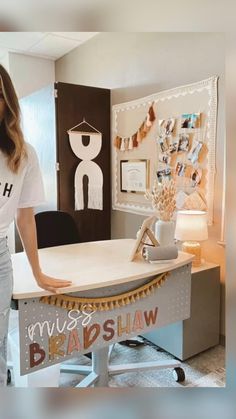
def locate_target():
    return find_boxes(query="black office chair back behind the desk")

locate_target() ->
[35,211,80,249]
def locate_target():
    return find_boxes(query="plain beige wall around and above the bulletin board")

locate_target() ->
[56,32,225,331]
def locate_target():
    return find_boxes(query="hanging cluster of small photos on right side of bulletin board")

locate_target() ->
[156,113,208,210]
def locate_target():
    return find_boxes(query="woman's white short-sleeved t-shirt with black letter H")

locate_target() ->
[0,143,45,238]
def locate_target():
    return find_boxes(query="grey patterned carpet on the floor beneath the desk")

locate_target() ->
[60,344,225,387]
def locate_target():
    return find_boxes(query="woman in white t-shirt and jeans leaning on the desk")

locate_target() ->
[0,65,71,386]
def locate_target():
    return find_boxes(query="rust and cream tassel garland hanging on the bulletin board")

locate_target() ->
[114,104,156,151]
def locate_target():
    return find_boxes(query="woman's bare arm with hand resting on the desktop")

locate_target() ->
[16,208,71,292]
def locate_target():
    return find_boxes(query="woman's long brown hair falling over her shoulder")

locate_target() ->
[0,65,26,173]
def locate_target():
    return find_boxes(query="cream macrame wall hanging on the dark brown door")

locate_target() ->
[67,119,103,211]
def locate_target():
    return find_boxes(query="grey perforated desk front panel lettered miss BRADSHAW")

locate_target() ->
[19,264,191,375]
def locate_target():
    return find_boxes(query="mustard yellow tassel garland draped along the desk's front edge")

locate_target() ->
[40,272,169,311]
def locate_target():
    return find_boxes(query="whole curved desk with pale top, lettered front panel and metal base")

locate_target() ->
[12,239,192,386]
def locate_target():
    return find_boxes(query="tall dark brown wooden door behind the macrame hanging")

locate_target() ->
[55,82,111,241]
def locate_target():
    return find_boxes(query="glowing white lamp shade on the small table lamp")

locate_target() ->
[175,210,208,241]
